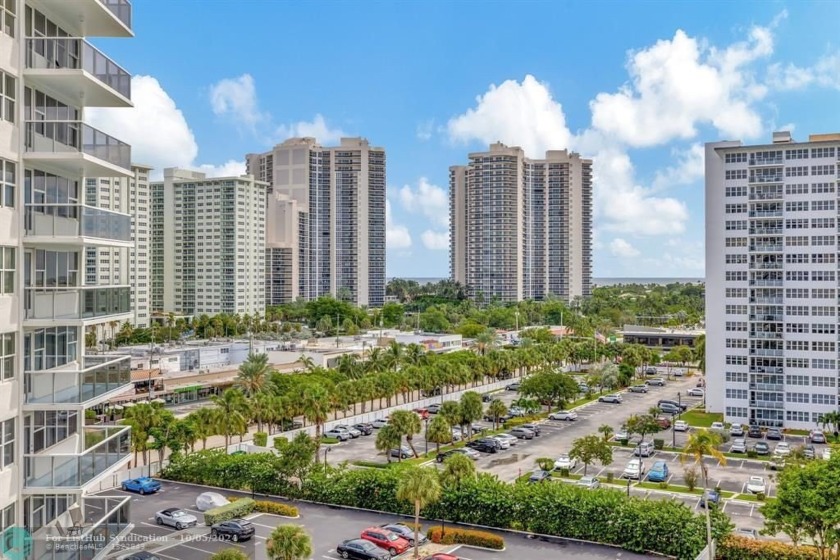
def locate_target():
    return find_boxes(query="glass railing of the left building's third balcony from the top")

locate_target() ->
[26,121,131,169]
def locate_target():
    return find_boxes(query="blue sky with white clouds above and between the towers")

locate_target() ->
[88,0,840,277]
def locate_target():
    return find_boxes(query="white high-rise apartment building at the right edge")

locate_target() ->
[706,132,840,429]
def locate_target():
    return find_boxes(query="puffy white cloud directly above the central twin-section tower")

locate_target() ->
[446,74,571,157]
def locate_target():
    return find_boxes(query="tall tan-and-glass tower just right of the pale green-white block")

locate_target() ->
[246,138,385,307]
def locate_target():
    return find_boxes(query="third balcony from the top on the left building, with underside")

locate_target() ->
[24,121,131,177]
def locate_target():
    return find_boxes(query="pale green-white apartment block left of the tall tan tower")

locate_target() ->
[150,168,268,316]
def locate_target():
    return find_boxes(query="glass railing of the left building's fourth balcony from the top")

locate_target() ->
[26,204,131,243]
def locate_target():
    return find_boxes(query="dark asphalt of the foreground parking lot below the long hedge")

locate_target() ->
[109,482,649,560]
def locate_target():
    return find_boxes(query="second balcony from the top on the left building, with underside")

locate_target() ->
[24,37,131,107]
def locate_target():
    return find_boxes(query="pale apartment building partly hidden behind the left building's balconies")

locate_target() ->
[85,164,152,328]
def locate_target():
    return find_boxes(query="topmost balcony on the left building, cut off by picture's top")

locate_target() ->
[39,0,134,37]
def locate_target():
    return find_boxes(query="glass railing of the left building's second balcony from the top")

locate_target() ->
[26,37,131,99]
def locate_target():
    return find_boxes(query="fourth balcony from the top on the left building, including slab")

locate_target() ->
[25,204,134,247]
